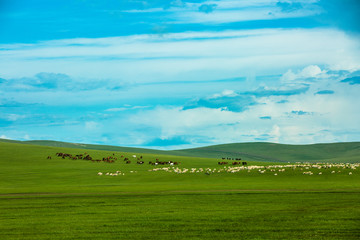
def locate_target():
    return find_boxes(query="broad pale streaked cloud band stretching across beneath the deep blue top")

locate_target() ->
[0,29,360,82]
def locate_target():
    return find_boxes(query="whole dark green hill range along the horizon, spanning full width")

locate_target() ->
[0,139,360,162]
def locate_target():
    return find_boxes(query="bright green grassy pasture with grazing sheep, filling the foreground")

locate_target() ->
[0,142,360,239]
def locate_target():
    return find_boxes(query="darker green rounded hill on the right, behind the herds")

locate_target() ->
[172,142,360,162]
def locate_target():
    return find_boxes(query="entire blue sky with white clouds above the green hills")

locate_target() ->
[0,0,360,149]
